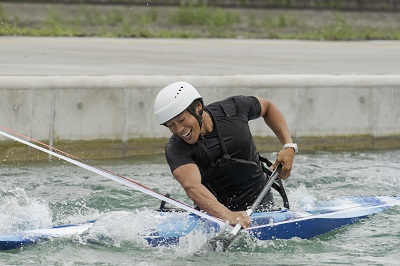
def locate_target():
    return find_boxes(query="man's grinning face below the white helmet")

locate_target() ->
[165,110,200,144]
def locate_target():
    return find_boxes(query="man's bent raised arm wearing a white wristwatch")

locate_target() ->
[257,97,295,179]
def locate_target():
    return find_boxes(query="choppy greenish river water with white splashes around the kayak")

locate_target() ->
[0,150,400,266]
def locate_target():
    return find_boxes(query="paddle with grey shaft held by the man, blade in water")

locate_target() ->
[208,165,282,252]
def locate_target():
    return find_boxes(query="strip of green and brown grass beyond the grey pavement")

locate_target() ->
[0,3,400,41]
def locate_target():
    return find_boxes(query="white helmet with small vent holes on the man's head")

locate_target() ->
[154,81,202,125]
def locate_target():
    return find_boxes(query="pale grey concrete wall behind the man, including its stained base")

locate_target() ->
[0,75,400,160]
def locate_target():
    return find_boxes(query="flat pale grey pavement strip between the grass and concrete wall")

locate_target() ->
[0,37,400,76]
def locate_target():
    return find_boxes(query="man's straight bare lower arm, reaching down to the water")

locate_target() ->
[173,164,250,228]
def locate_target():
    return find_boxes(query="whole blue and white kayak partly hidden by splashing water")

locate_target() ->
[0,196,400,250]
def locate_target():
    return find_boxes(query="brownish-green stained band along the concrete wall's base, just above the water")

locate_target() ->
[0,135,400,163]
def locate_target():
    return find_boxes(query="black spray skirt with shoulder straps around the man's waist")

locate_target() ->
[200,109,289,211]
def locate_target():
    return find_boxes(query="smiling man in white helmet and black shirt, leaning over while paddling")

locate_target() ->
[154,81,297,228]
